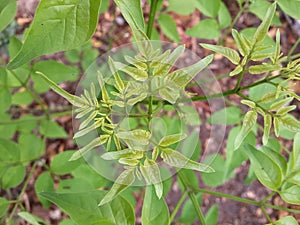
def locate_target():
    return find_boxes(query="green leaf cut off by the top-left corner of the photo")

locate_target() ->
[0,0,17,32]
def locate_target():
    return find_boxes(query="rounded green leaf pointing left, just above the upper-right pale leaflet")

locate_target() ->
[186,19,221,39]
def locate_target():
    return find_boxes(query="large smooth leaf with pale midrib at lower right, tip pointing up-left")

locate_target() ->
[245,144,283,190]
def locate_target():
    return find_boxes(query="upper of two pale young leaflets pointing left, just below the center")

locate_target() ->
[117,129,151,145]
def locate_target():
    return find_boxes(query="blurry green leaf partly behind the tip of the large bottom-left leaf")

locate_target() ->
[34,172,54,209]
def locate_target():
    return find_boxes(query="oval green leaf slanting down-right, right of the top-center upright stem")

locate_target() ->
[157,14,181,43]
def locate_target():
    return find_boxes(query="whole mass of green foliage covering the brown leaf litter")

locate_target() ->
[0,0,300,225]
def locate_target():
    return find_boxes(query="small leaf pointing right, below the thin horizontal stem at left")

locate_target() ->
[39,120,68,138]
